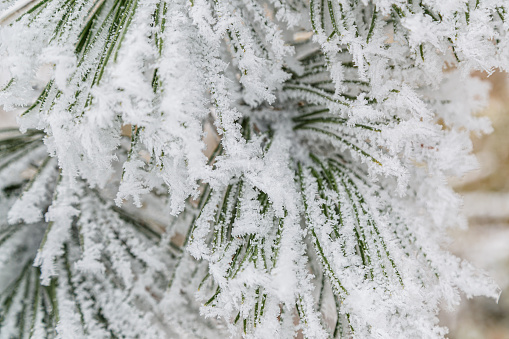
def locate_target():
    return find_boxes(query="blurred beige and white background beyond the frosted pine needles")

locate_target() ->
[0,72,509,339]
